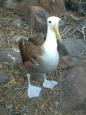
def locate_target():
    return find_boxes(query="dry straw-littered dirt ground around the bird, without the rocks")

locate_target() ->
[0,9,85,115]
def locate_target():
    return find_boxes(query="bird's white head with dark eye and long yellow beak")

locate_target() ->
[47,16,62,42]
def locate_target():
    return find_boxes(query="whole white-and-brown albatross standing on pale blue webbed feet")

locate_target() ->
[19,16,62,97]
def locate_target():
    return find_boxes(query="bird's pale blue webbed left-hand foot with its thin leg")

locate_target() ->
[27,74,41,98]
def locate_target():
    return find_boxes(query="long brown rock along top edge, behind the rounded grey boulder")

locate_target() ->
[11,0,64,16]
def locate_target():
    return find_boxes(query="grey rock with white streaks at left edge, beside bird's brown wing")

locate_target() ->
[0,48,22,66]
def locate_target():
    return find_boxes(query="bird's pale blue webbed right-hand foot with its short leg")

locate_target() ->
[43,75,58,89]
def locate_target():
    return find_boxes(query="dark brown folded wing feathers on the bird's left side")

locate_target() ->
[19,38,42,66]
